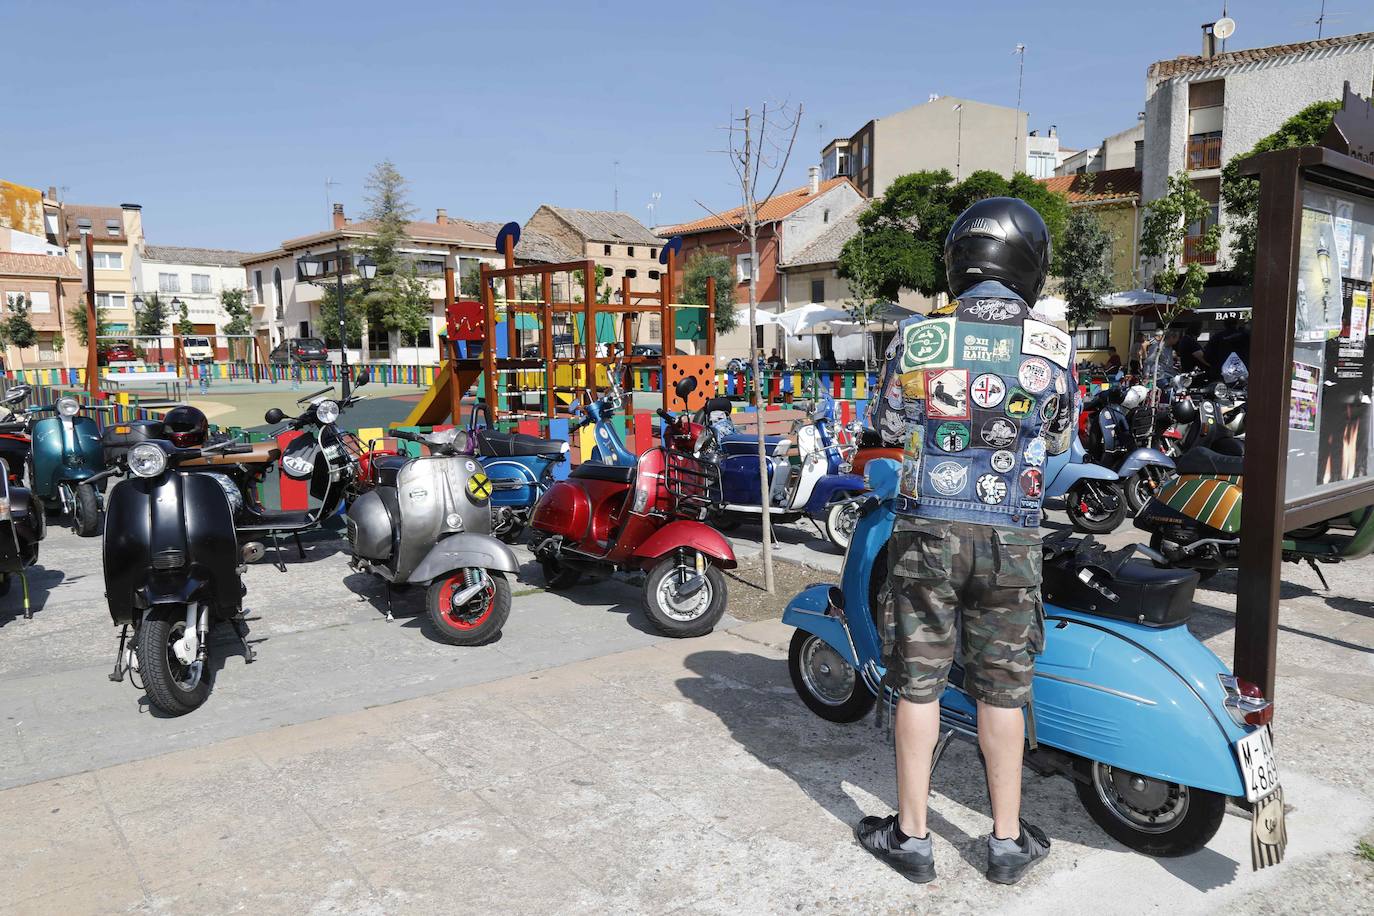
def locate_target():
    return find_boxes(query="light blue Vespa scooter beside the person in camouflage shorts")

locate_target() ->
[783,455,1282,856]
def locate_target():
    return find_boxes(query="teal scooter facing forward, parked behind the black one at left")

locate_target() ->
[26,397,111,537]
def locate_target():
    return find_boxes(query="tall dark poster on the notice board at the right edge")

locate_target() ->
[1316,277,1374,485]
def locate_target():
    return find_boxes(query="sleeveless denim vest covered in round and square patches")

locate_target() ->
[868,280,1074,527]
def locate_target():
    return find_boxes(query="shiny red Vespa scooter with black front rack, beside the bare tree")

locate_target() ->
[530,378,736,637]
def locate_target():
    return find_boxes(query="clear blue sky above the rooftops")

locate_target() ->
[0,0,1374,250]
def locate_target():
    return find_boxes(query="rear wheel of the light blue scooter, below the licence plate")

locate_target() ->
[1074,758,1226,858]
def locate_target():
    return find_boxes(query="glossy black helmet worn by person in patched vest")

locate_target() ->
[945,198,1050,305]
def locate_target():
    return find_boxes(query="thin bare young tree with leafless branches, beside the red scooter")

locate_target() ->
[697,102,802,593]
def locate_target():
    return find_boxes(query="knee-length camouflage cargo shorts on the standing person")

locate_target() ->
[883,515,1044,707]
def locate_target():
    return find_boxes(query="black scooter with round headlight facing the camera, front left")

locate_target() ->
[98,436,253,715]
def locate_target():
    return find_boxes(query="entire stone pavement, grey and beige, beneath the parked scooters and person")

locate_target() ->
[0,519,1374,916]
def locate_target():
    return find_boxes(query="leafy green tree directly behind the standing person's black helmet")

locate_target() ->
[840,169,1069,301]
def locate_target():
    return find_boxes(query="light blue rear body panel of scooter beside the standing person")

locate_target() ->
[1033,604,1246,795]
